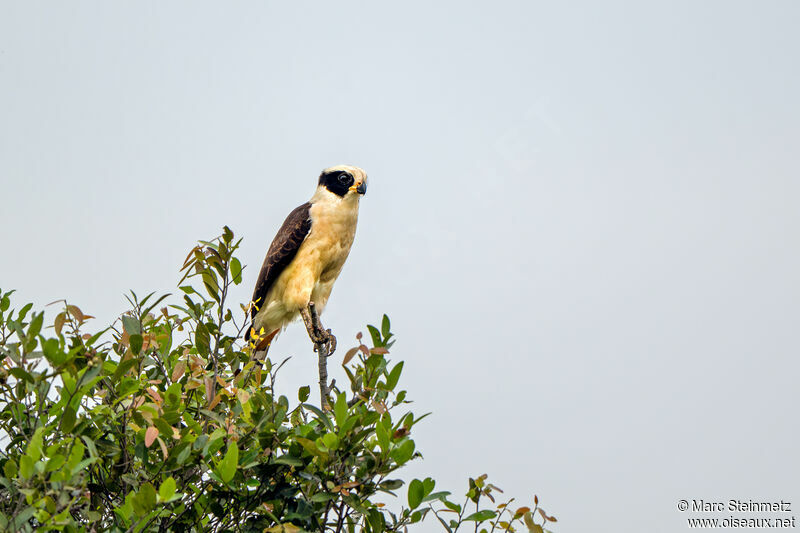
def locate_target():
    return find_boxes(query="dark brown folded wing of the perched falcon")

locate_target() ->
[245,202,311,340]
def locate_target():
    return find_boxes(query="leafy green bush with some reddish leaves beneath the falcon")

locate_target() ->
[0,227,555,533]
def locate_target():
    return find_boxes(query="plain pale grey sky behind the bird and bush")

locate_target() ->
[0,0,800,533]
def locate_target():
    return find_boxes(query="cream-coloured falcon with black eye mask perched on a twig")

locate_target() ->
[245,165,367,350]
